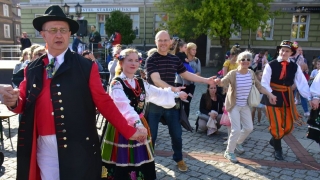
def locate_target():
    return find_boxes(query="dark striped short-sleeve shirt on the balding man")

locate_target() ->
[146,52,186,86]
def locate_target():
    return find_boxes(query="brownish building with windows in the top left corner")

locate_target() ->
[0,0,21,45]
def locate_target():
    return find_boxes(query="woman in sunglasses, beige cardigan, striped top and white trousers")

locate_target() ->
[215,51,276,163]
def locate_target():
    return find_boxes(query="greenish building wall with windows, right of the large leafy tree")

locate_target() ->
[210,0,320,62]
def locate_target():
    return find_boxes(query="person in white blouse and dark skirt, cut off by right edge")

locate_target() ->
[307,70,320,144]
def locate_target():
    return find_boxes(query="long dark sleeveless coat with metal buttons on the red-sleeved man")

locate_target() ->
[17,49,101,180]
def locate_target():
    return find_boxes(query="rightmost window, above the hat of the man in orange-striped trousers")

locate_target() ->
[291,14,310,40]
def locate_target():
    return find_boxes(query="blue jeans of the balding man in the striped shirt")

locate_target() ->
[147,103,182,162]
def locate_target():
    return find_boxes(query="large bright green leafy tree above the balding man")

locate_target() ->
[156,0,277,60]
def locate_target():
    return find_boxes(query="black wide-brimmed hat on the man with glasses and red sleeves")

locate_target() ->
[32,5,79,34]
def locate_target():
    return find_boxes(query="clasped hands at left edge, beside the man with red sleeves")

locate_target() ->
[0,85,20,107]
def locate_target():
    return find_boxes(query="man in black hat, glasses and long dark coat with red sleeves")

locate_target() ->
[0,5,147,180]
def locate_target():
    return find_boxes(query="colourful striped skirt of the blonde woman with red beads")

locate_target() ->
[101,117,156,180]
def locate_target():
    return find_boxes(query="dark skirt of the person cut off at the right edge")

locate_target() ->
[307,108,320,144]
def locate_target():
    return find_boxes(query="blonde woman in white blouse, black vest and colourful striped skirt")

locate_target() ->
[101,49,188,180]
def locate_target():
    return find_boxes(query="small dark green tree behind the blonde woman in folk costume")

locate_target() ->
[104,11,136,45]
